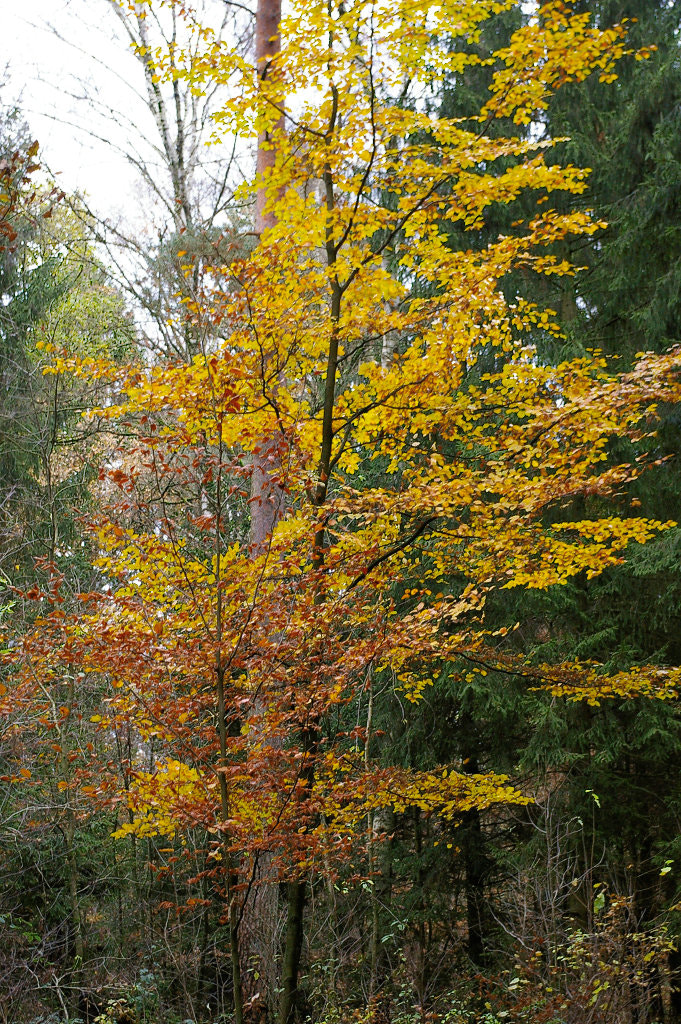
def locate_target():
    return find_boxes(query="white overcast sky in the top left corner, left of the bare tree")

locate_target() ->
[0,0,152,214]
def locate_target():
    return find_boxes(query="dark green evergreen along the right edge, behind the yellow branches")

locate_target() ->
[382,6,681,1019]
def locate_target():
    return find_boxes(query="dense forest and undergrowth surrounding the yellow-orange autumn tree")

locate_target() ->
[0,0,681,1024]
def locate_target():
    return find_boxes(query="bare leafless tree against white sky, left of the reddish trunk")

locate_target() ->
[94,0,252,359]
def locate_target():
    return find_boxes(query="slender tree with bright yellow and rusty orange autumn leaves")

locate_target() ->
[10,0,679,1024]
